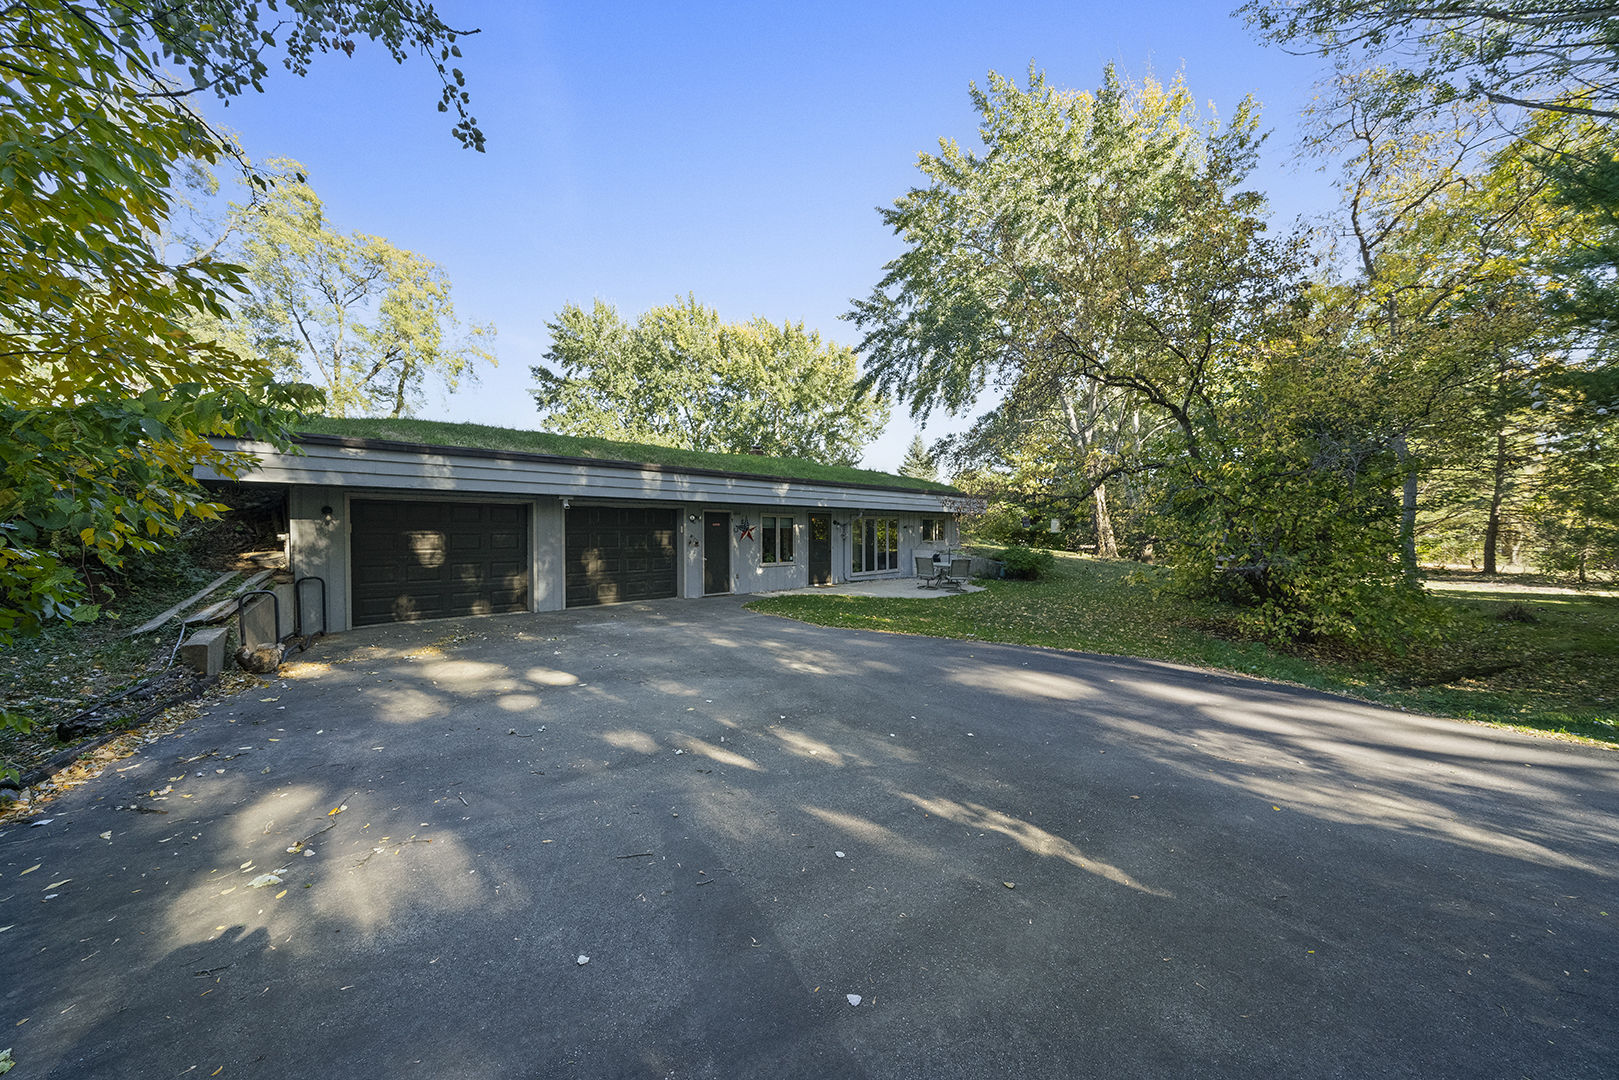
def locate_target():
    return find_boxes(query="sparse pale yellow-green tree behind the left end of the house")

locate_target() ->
[223,160,495,416]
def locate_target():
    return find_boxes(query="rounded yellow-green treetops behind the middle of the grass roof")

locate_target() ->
[533,296,887,465]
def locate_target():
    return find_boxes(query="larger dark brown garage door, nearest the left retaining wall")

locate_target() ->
[350,499,529,627]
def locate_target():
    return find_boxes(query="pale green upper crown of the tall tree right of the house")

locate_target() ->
[847,68,1290,433]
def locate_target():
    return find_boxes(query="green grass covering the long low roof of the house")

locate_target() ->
[301,416,957,494]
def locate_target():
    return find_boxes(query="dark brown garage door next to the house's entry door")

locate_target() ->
[567,507,675,607]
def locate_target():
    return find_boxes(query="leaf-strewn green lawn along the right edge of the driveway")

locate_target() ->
[748,552,1619,745]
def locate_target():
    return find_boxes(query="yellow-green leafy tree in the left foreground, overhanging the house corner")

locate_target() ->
[0,0,482,660]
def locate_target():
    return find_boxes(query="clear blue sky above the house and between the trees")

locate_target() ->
[206,0,1334,470]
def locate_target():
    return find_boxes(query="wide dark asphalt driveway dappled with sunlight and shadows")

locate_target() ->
[0,599,1619,1080]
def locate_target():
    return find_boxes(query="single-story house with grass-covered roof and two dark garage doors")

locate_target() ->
[199,421,965,631]
